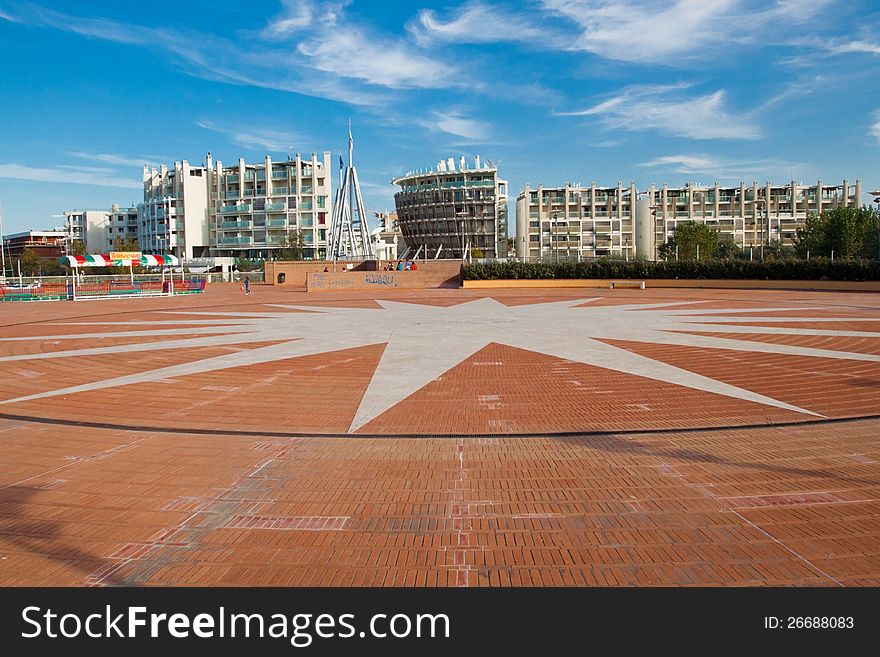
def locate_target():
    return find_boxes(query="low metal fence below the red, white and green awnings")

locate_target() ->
[0,274,207,301]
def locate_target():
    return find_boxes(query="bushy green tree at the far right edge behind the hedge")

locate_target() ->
[794,207,878,258]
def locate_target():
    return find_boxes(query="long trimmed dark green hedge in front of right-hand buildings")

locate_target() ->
[461,258,880,281]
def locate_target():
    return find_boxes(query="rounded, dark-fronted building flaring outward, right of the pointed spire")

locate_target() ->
[391,156,507,258]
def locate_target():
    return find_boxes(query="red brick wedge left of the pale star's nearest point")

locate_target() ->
[8,343,384,433]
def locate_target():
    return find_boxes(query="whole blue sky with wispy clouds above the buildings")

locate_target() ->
[0,0,880,232]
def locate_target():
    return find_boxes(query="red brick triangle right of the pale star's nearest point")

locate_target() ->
[358,344,805,434]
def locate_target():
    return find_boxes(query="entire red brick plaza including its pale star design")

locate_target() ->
[0,285,880,586]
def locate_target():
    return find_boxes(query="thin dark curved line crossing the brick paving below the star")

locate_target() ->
[0,413,880,439]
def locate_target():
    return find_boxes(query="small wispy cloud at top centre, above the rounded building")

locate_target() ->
[407,1,549,47]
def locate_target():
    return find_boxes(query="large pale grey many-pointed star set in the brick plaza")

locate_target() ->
[0,297,880,433]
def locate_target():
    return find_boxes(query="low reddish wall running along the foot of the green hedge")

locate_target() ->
[462,278,880,292]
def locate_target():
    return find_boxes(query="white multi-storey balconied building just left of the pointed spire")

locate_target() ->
[138,152,332,259]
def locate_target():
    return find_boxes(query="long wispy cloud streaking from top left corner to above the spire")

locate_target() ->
[1,2,446,107]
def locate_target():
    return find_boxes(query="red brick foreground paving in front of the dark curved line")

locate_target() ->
[0,421,880,586]
